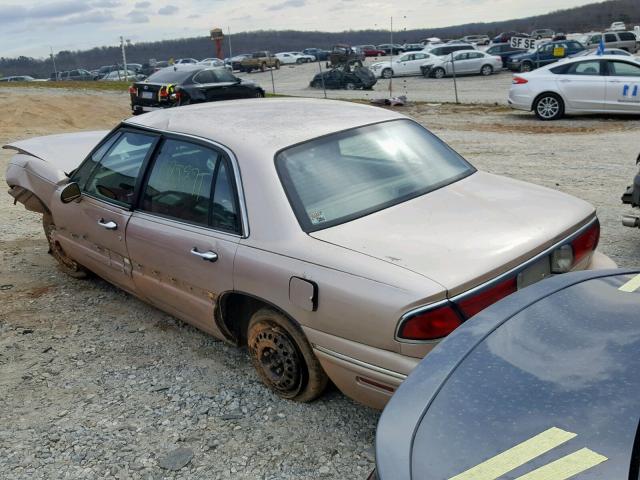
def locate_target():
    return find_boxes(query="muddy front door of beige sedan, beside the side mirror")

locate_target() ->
[51,129,158,291]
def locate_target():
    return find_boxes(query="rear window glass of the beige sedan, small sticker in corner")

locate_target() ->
[276,120,475,232]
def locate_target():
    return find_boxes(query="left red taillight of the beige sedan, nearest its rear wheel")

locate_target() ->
[398,303,462,340]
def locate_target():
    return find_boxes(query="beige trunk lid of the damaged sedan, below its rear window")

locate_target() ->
[311,172,594,295]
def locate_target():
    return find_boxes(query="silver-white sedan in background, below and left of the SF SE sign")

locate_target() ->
[420,50,502,78]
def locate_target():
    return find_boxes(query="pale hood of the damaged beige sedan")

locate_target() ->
[3,130,109,173]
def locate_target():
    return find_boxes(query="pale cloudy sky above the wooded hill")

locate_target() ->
[0,0,594,57]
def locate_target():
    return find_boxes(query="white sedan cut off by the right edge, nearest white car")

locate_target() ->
[509,55,640,120]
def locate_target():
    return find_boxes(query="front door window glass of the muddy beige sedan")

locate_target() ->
[85,132,156,207]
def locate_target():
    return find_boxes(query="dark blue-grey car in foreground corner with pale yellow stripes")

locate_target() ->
[372,269,640,480]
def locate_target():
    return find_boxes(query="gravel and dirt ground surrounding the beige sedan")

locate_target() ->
[0,88,640,479]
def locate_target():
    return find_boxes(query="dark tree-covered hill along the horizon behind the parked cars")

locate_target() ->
[0,0,640,78]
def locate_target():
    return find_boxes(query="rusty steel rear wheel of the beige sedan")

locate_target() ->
[247,308,328,402]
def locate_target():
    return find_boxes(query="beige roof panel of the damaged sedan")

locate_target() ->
[125,98,406,158]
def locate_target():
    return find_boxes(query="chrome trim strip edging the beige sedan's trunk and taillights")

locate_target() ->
[394,215,598,344]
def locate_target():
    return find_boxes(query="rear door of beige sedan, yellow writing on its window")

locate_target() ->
[126,136,243,336]
